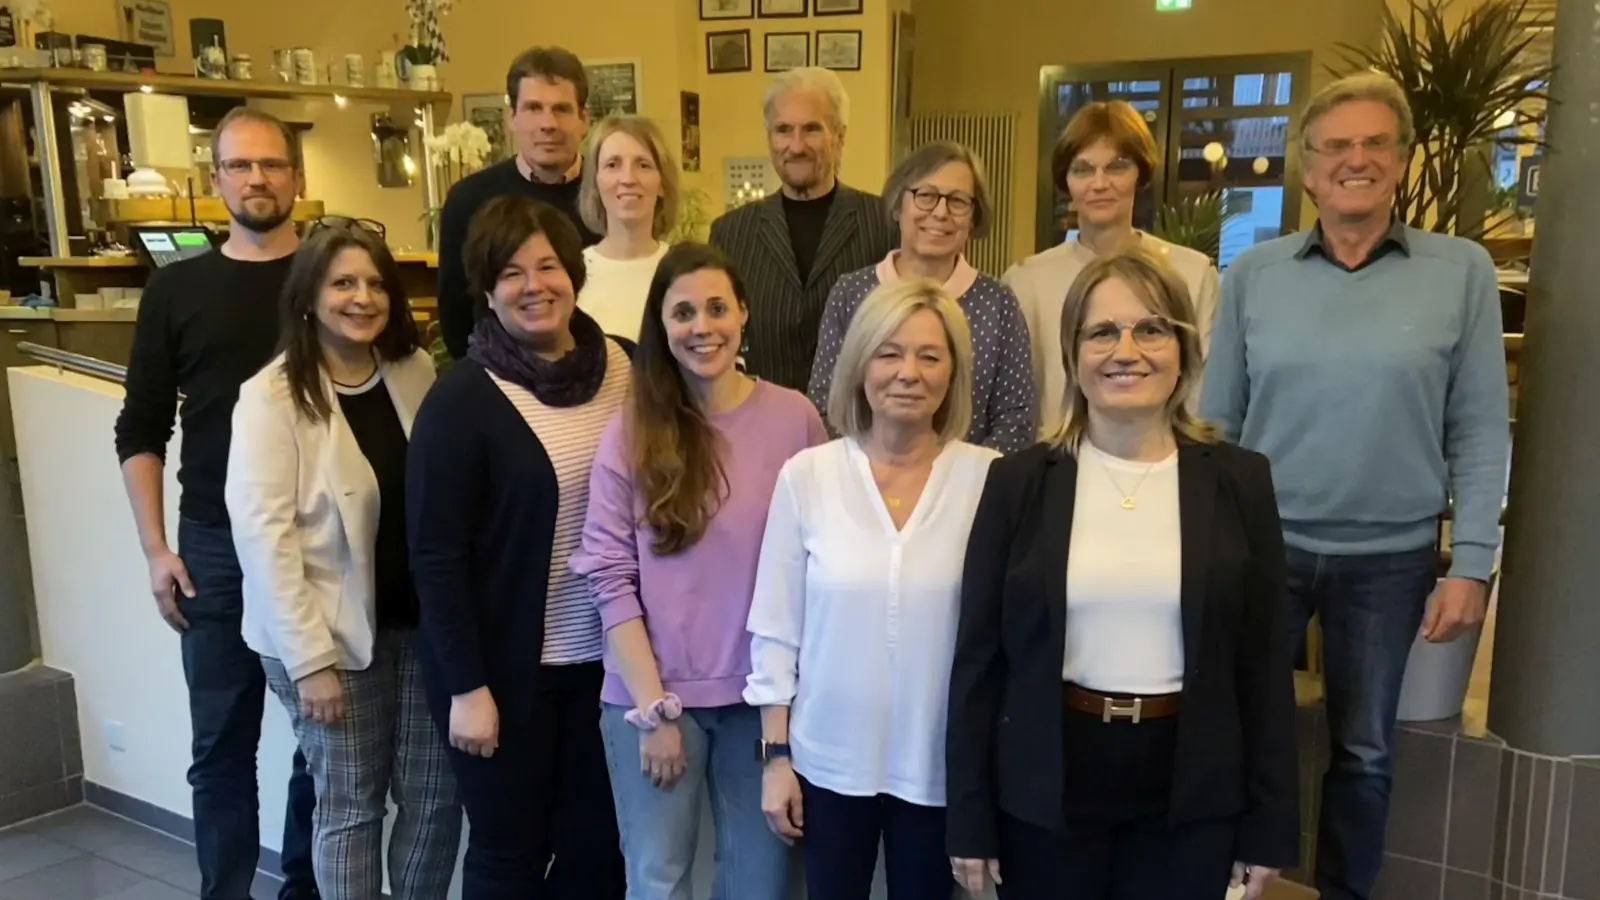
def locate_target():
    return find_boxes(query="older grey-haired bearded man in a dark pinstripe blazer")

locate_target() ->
[710,69,899,391]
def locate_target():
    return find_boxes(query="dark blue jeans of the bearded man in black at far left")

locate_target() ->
[178,519,317,900]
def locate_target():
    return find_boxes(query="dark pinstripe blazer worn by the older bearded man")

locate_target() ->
[710,184,899,394]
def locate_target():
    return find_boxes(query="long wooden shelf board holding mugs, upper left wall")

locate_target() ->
[0,69,451,114]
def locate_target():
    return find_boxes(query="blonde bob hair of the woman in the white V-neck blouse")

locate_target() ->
[827,279,973,444]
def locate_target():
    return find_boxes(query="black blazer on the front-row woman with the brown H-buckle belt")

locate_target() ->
[946,440,1299,868]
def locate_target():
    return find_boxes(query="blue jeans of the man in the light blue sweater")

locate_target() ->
[1288,538,1438,900]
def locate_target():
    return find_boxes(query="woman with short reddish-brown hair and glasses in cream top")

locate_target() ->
[1005,99,1218,436]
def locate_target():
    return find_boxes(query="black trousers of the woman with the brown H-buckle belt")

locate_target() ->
[1000,708,1237,900]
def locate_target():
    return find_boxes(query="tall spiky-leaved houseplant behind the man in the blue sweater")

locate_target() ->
[1333,0,1554,239]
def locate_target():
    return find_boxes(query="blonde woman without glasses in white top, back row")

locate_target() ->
[578,115,678,341]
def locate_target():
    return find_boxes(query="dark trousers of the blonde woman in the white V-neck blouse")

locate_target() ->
[800,778,940,900]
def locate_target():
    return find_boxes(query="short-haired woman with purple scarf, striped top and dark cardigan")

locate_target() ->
[406,197,629,900]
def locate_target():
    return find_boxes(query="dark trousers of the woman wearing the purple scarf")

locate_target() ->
[451,663,626,900]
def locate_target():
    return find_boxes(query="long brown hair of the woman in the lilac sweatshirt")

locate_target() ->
[627,243,749,556]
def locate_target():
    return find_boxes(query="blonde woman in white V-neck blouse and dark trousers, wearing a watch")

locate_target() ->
[744,279,998,900]
